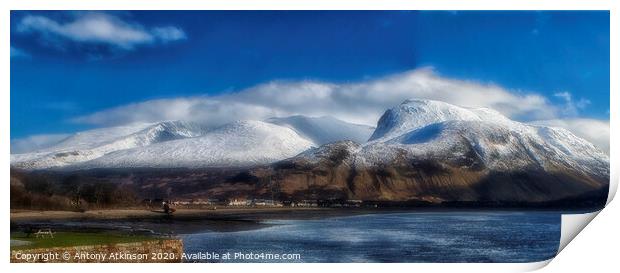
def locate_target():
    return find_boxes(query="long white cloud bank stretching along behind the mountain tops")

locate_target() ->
[74,68,561,126]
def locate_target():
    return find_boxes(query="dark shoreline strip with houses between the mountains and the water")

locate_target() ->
[11,207,565,239]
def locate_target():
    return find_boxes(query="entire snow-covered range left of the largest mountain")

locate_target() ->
[11,113,373,169]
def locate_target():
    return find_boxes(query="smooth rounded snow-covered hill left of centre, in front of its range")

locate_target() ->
[74,121,314,169]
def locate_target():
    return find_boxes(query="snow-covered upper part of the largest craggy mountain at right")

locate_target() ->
[362,100,609,174]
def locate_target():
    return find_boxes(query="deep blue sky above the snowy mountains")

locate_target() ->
[11,11,609,142]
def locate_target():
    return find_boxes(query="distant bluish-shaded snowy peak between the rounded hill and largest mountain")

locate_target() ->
[267,115,375,145]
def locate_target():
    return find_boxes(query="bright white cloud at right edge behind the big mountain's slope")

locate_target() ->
[532,118,610,154]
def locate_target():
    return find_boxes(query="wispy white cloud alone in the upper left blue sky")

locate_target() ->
[18,12,186,50]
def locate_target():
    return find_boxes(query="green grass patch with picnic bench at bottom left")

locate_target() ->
[11,232,159,250]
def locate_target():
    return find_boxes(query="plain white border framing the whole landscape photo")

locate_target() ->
[0,0,620,273]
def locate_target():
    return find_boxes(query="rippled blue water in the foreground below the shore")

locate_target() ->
[183,212,560,262]
